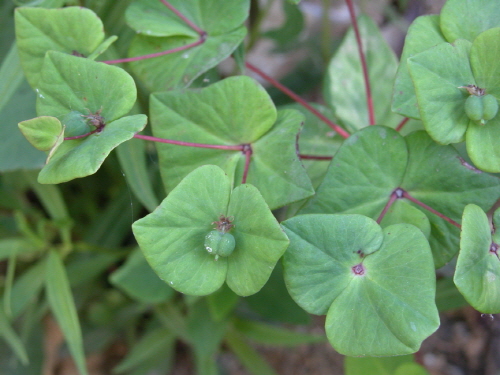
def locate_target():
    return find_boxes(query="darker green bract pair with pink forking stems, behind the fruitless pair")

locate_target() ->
[301,126,500,267]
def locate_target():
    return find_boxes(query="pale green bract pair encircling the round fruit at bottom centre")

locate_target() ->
[132,165,288,296]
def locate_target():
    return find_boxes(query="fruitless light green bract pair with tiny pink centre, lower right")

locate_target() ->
[283,215,439,356]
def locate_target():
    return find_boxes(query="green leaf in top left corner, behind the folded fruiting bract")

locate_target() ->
[15,7,106,87]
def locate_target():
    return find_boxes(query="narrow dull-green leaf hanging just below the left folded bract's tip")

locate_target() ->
[116,138,159,212]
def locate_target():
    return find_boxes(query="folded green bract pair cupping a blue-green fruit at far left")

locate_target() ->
[22,52,147,184]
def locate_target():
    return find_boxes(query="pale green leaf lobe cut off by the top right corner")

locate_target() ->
[441,0,500,43]
